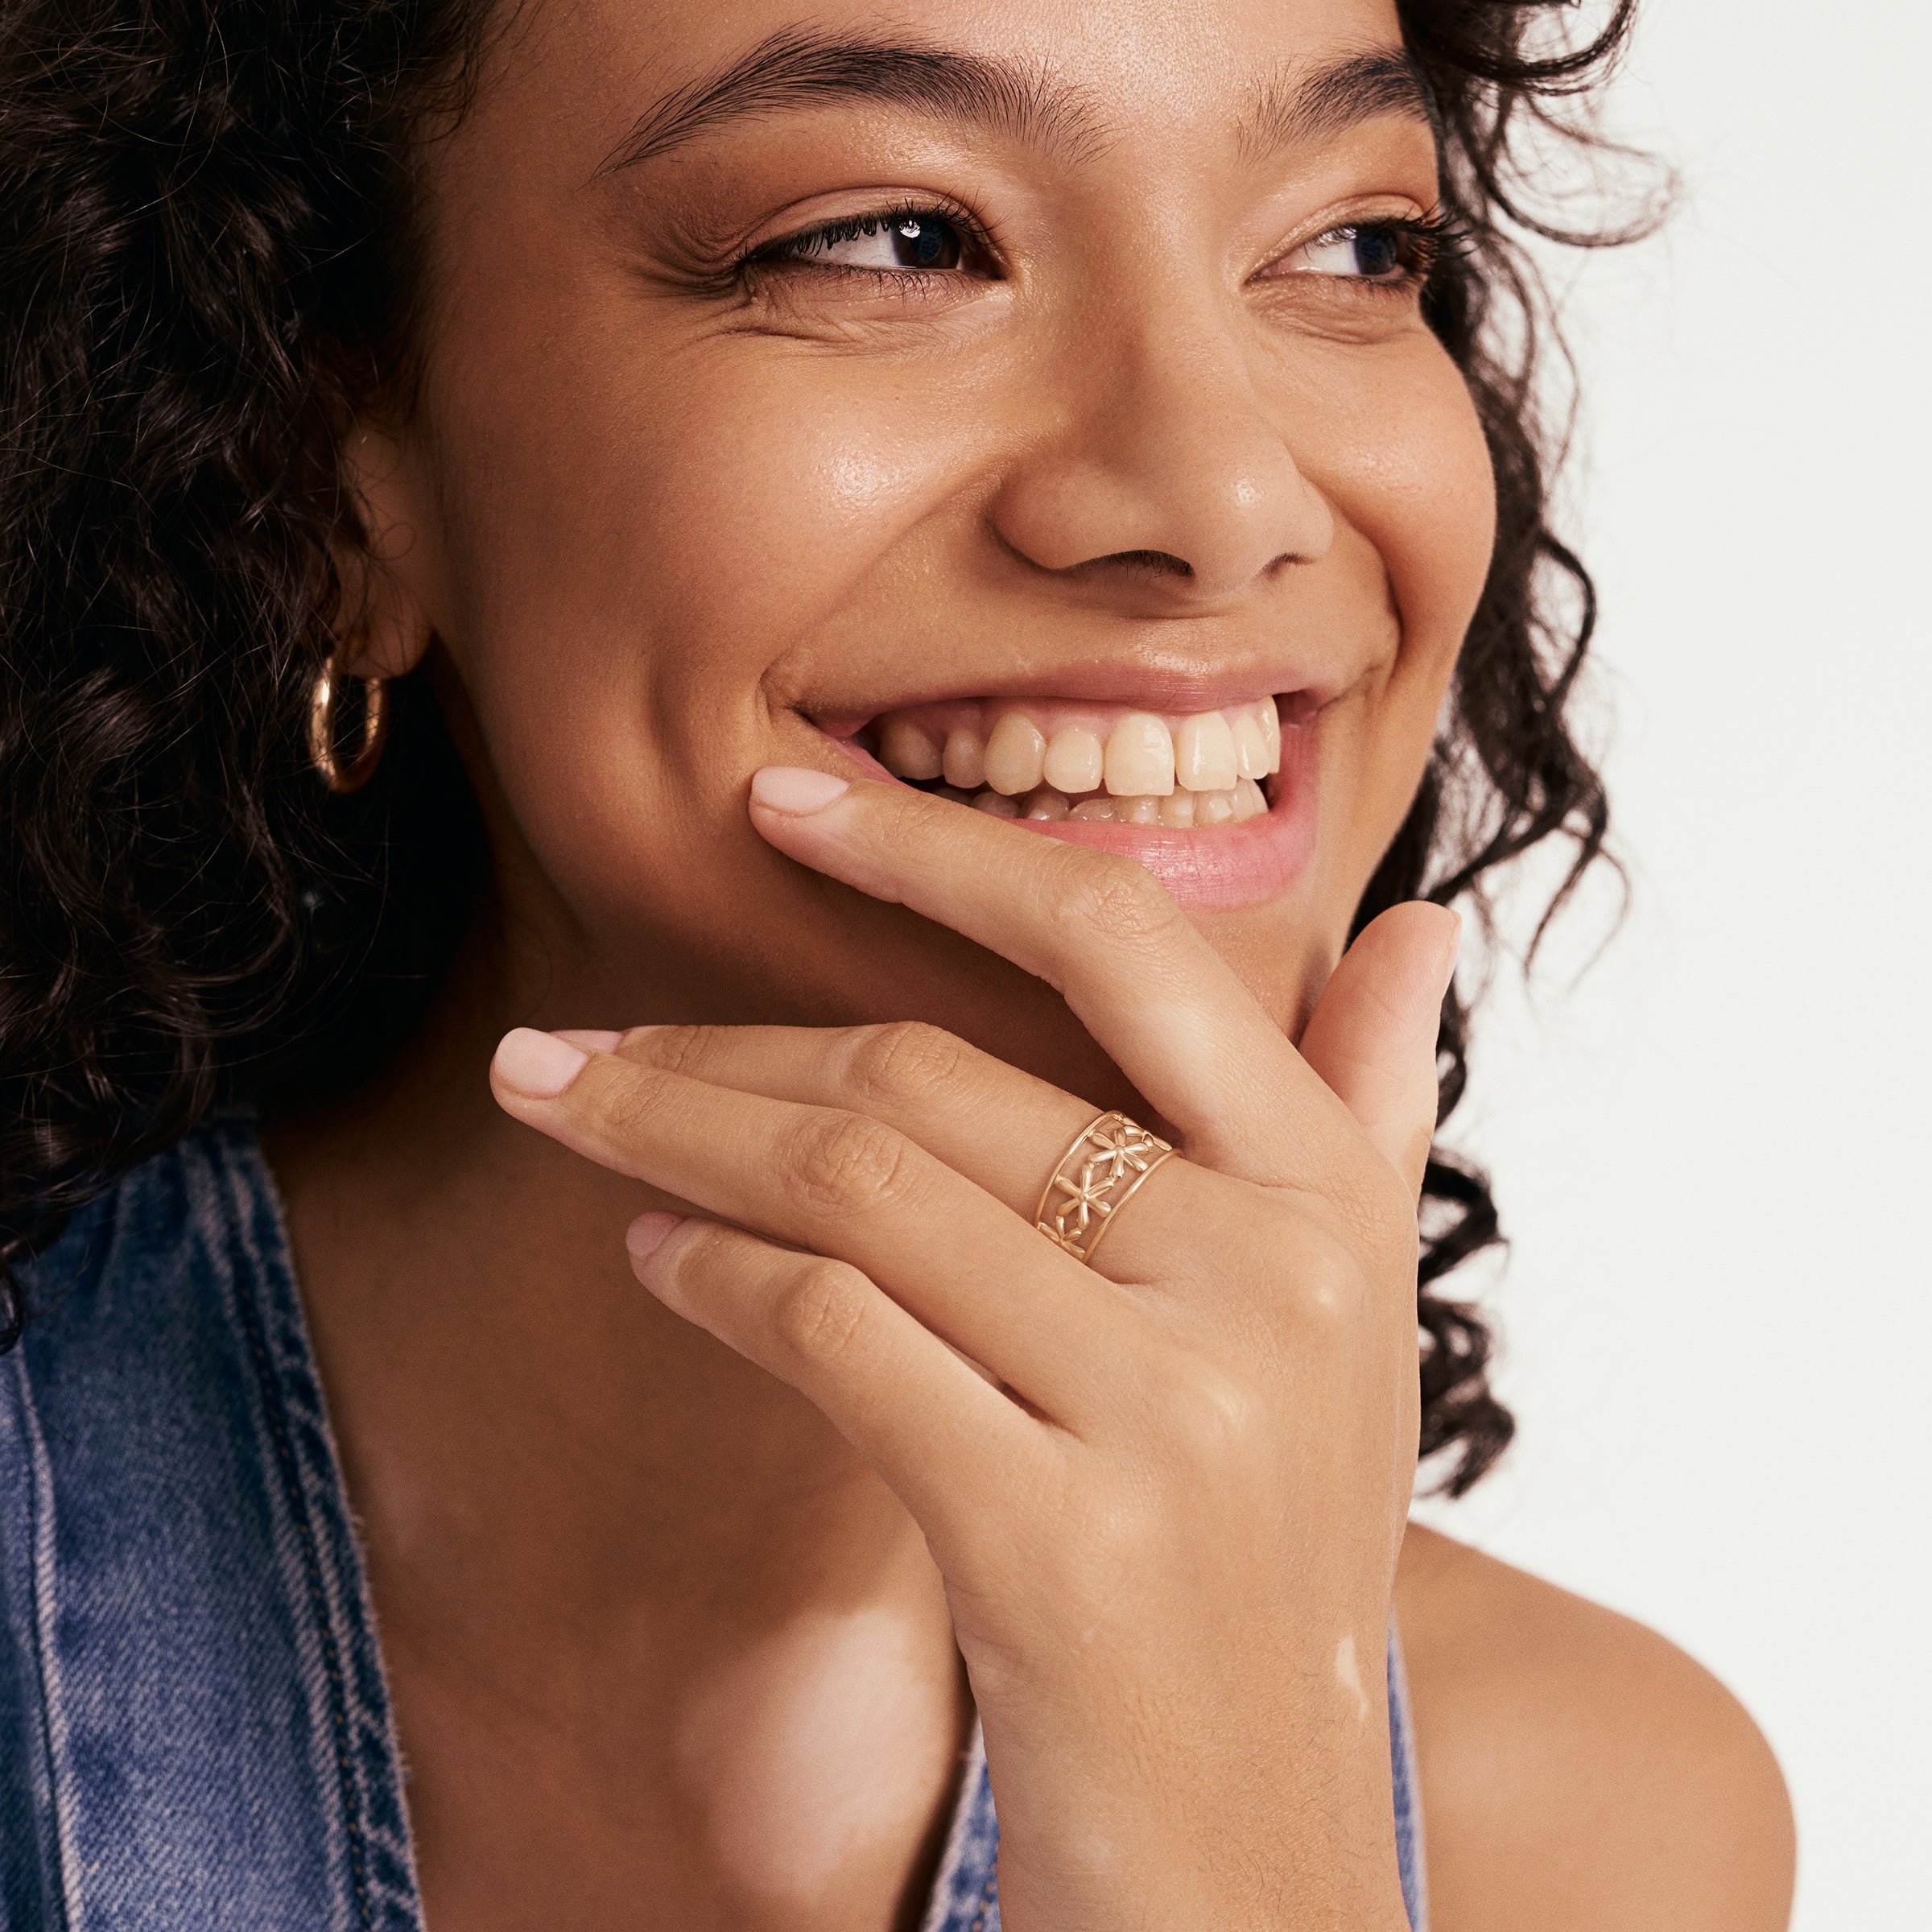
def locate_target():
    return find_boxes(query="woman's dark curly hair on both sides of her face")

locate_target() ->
[0,0,1662,1493]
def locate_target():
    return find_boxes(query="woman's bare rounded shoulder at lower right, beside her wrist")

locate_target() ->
[1395,1526,1793,1932]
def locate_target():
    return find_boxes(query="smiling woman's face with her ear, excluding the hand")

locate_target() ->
[369,0,1493,1093]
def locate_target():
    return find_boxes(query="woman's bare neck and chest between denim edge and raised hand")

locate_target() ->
[265,807,972,1928]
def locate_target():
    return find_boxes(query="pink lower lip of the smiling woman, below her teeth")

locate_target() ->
[835,724,1315,912]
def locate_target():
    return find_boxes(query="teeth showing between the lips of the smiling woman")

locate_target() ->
[846,696,1294,831]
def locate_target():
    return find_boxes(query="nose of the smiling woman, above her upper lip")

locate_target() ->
[991,317,1335,603]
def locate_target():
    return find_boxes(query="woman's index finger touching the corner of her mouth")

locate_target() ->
[752,771,1360,1187]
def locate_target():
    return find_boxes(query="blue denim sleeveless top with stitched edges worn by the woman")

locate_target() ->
[0,1115,1424,1932]
